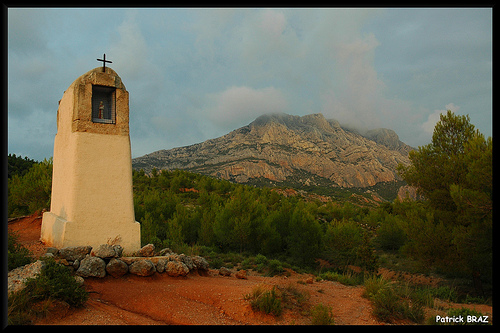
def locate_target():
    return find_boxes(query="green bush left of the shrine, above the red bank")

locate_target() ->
[8,158,52,216]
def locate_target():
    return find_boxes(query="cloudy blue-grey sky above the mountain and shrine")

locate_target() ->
[8,8,493,160]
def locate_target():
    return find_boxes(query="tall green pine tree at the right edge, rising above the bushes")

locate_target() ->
[398,111,493,294]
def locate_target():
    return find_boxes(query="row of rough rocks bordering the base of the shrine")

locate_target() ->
[44,244,209,278]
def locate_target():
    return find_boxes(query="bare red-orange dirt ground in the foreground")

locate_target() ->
[8,215,492,325]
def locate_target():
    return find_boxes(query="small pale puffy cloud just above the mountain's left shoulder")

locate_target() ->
[203,86,287,129]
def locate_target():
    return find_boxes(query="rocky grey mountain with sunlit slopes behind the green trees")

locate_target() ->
[132,113,413,193]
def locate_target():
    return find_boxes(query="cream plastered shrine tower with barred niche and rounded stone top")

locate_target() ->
[41,65,141,253]
